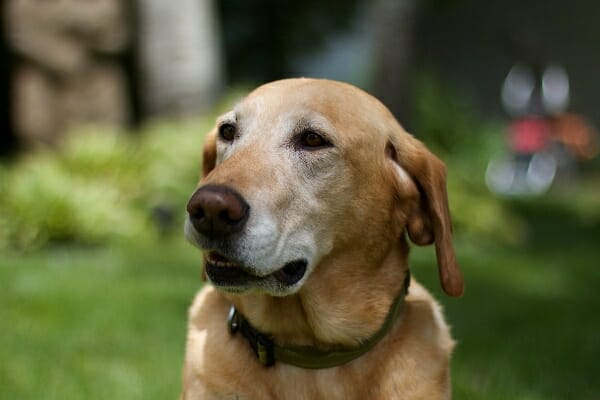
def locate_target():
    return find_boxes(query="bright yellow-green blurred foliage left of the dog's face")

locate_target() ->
[0,120,212,250]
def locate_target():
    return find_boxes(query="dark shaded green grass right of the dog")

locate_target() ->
[413,198,600,399]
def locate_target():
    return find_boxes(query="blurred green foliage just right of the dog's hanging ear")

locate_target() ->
[413,72,527,244]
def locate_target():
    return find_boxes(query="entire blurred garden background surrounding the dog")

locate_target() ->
[0,0,600,399]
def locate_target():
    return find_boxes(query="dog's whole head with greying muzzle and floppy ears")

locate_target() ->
[186,79,463,296]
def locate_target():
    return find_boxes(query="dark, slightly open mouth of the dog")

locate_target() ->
[205,251,308,287]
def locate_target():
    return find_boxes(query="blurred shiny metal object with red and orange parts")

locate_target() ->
[485,63,599,196]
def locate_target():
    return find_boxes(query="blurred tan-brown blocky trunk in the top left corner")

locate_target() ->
[3,0,130,143]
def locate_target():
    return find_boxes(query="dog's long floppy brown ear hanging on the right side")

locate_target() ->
[393,133,464,297]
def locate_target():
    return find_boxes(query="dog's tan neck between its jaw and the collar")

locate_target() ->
[227,242,408,348]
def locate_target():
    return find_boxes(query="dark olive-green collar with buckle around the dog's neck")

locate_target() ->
[227,271,410,369]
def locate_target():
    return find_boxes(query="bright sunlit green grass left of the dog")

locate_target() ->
[0,240,200,400]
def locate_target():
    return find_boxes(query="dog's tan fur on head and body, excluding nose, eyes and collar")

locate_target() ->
[182,79,463,400]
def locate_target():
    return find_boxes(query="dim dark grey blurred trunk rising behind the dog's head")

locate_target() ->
[373,0,421,128]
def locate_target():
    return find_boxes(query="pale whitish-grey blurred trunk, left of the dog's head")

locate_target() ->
[137,0,222,116]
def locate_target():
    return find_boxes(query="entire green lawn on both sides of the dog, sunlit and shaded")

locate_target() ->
[0,198,600,400]
